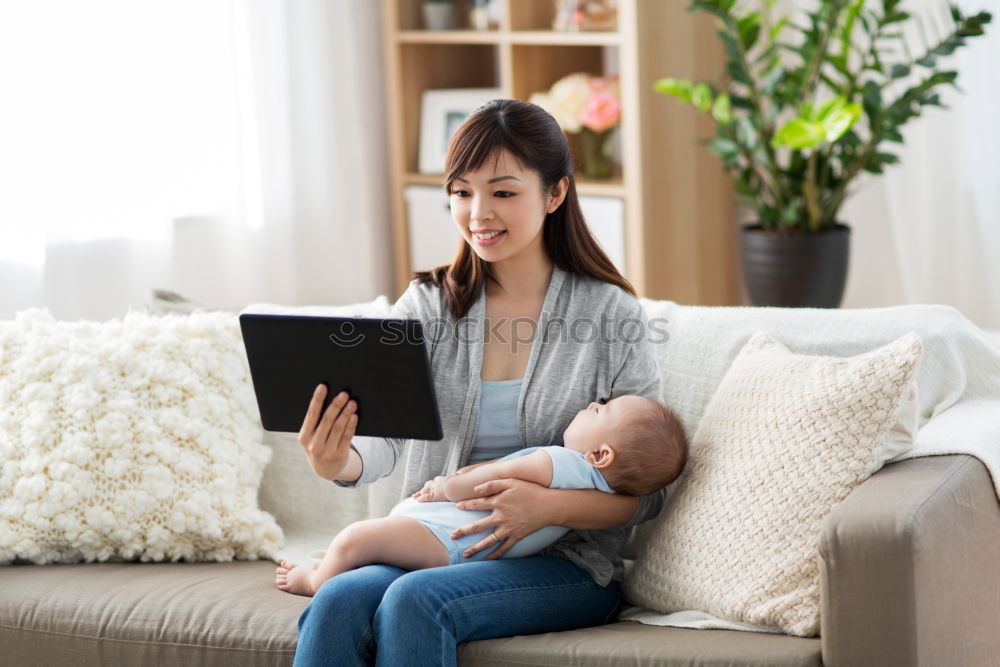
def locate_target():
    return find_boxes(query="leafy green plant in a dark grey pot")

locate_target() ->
[655,0,991,308]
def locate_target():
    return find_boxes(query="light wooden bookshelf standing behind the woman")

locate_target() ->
[381,0,739,305]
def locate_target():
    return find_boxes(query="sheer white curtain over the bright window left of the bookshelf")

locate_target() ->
[0,0,391,319]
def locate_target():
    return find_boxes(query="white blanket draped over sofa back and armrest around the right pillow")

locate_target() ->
[620,299,1000,633]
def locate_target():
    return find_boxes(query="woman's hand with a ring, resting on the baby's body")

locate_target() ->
[451,479,552,560]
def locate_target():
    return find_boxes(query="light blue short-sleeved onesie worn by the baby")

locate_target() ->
[389,445,614,565]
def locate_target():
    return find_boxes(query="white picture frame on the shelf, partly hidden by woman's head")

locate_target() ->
[417,88,504,174]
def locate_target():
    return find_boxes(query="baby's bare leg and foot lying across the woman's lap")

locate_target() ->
[276,516,448,596]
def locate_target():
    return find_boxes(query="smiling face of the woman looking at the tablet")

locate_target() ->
[449,151,568,262]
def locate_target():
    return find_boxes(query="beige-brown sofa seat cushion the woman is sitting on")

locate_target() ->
[0,562,822,667]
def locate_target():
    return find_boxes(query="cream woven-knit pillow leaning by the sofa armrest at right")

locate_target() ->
[625,333,923,637]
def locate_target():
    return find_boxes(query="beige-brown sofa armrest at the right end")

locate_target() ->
[818,454,1000,667]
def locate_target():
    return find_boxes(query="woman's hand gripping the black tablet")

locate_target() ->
[299,384,358,480]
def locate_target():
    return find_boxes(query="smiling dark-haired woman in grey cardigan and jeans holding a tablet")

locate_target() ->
[295,100,663,666]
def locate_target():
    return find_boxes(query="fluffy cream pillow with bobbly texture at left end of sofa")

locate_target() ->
[0,309,283,563]
